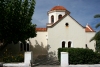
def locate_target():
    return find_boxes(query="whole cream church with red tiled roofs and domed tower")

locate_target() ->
[2,6,96,57]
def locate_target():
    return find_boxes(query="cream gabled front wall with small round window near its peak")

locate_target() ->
[48,15,94,54]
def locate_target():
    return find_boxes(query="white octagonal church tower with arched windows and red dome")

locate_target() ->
[48,6,70,25]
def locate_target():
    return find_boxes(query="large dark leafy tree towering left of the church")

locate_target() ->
[0,0,36,49]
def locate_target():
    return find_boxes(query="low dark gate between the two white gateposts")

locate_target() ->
[34,55,60,65]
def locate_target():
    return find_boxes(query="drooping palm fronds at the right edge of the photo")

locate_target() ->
[90,14,100,52]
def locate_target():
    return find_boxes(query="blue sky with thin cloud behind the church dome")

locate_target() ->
[32,0,100,30]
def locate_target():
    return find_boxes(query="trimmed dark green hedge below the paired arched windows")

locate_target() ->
[58,48,100,64]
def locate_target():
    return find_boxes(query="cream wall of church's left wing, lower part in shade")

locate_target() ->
[30,31,48,60]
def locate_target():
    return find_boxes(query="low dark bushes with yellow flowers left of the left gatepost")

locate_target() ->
[0,49,24,63]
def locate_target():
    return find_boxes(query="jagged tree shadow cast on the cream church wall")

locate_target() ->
[30,40,57,60]
